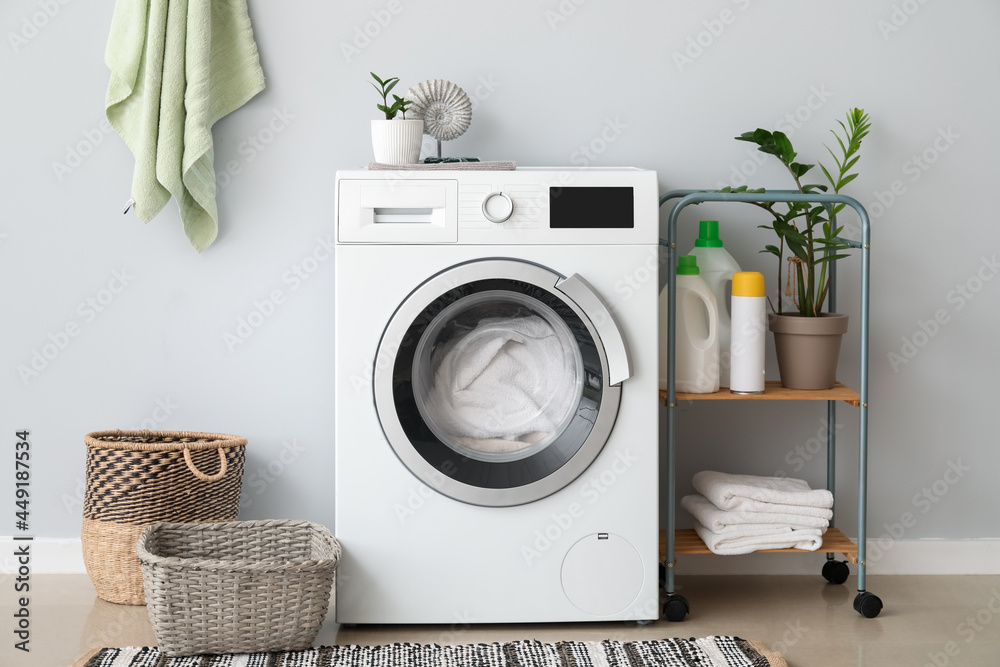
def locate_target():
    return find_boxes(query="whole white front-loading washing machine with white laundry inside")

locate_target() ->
[334,168,659,625]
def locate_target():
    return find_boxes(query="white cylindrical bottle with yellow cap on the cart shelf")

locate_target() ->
[729,271,767,394]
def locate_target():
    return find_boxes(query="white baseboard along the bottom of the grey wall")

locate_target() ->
[0,537,1000,579]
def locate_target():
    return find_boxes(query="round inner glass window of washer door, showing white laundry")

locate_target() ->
[412,290,583,462]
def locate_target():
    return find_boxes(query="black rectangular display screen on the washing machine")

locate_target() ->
[549,186,635,229]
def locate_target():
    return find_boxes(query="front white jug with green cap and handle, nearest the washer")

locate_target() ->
[660,255,719,394]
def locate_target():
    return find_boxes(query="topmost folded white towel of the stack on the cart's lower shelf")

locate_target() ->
[693,470,833,520]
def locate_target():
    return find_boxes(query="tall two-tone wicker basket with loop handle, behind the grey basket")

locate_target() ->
[81,431,247,604]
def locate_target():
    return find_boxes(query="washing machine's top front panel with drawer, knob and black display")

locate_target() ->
[337,168,659,244]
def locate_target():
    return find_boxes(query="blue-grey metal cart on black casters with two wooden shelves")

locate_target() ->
[660,190,882,621]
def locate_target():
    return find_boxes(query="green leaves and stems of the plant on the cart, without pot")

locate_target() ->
[721,108,871,317]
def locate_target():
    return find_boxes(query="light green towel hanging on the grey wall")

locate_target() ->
[105,0,264,252]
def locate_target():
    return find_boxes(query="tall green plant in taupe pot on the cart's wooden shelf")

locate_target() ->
[723,108,871,389]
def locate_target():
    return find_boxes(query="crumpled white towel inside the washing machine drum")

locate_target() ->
[425,315,579,453]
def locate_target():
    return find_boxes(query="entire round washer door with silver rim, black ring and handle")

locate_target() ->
[373,259,632,507]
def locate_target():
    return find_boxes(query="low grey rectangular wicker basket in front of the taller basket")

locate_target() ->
[136,520,340,656]
